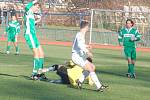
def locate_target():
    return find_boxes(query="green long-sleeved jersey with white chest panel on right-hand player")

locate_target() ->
[118,27,141,47]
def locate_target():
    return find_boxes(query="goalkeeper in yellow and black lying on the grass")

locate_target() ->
[38,58,108,92]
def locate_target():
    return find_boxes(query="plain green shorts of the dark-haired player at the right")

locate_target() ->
[124,47,136,60]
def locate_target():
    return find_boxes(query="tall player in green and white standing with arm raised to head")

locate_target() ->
[24,0,46,80]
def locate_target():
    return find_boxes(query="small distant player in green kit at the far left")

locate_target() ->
[6,12,20,54]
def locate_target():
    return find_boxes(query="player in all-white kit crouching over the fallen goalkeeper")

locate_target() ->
[72,21,108,92]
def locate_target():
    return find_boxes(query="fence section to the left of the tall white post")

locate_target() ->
[0,11,90,42]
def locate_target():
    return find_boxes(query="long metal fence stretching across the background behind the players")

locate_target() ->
[0,9,150,47]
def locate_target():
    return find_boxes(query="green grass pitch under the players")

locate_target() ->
[0,42,150,100]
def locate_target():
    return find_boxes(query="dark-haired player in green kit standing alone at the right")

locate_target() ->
[118,19,141,78]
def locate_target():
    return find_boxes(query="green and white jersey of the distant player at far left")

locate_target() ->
[6,20,20,37]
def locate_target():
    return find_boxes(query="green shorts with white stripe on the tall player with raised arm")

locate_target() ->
[24,34,40,49]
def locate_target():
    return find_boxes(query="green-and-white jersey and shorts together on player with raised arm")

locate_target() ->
[24,1,40,49]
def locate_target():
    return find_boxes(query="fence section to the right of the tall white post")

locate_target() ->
[90,9,150,47]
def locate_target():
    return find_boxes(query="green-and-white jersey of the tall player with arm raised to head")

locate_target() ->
[24,2,36,35]
